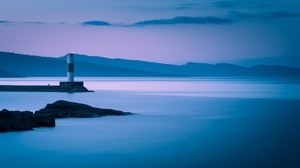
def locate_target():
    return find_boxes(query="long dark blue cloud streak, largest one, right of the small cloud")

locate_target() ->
[134,16,233,26]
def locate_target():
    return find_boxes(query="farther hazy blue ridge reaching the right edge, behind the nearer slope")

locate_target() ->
[61,55,300,77]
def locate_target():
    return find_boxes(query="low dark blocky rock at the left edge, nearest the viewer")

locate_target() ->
[0,109,55,132]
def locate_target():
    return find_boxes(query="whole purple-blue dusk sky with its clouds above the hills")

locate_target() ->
[0,0,300,64]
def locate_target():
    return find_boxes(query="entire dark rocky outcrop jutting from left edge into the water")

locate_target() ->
[0,100,132,132]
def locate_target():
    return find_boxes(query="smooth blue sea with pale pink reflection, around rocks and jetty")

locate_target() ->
[0,77,300,168]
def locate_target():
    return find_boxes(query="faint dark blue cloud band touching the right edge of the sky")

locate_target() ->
[229,11,300,20]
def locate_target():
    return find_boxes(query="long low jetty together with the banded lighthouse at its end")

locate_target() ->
[0,53,92,93]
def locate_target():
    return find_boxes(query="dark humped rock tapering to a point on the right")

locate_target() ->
[35,100,132,118]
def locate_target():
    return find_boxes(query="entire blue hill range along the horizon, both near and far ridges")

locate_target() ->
[0,52,300,77]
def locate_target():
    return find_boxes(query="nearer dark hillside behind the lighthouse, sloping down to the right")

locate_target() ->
[0,52,176,77]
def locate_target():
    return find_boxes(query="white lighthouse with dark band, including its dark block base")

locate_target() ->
[59,53,88,92]
